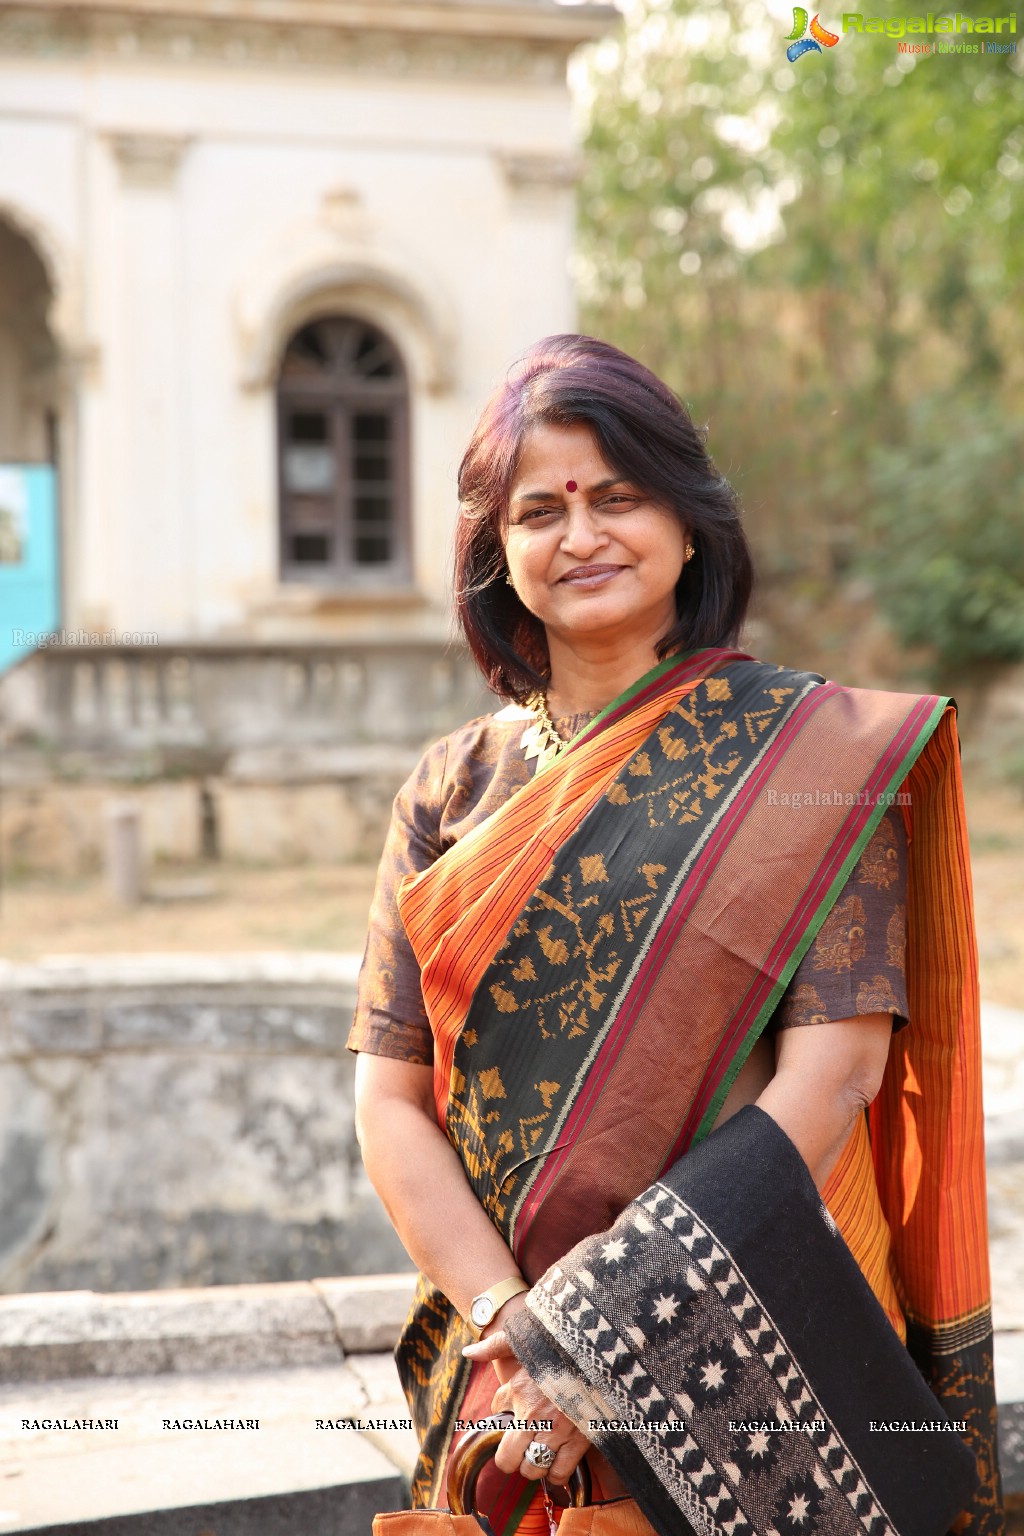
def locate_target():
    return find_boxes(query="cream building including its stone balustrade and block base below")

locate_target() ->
[0,0,616,869]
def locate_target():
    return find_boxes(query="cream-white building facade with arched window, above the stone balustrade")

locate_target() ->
[0,0,614,647]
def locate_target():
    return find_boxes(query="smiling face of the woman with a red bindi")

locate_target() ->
[505,425,686,650]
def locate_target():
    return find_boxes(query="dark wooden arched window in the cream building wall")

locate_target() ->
[278,316,410,585]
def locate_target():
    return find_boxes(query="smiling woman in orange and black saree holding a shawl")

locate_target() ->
[348,336,1001,1536]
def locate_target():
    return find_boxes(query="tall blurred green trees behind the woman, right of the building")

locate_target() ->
[577,0,1024,672]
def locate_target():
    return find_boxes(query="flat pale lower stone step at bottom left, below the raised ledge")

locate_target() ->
[0,1356,411,1536]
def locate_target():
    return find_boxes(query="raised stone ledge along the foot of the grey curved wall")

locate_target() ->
[0,1275,415,1382]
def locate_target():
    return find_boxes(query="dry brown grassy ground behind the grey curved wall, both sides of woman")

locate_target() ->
[0,779,1024,1008]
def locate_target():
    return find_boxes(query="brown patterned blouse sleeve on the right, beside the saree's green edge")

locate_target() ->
[768,808,909,1034]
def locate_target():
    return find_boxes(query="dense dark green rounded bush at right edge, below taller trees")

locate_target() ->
[860,399,1024,677]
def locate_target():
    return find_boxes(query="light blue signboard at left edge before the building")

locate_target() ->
[0,464,60,673]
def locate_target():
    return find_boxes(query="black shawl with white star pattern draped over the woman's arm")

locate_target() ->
[508,1106,976,1536]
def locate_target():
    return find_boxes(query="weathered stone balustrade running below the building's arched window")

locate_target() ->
[0,639,490,768]
